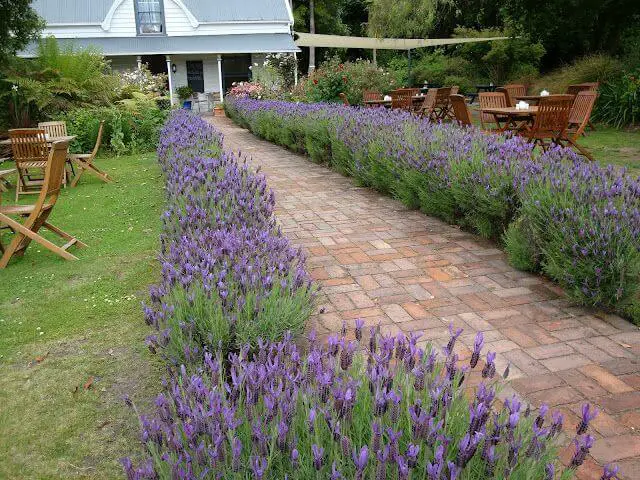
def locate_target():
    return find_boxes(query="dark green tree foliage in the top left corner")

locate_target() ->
[0,0,44,63]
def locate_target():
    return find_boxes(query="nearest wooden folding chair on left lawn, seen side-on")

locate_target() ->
[0,142,86,269]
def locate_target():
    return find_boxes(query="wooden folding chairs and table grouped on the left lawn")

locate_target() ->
[0,122,112,269]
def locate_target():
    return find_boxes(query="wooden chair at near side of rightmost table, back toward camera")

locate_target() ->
[520,95,573,150]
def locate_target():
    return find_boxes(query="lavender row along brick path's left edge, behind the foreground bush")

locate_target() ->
[145,110,313,362]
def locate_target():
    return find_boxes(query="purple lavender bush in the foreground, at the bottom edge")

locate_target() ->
[123,321,617,480]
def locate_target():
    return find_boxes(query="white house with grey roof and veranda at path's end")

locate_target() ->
[22,0,297,101]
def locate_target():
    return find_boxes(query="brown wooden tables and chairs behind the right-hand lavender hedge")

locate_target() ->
[348,83,598,160]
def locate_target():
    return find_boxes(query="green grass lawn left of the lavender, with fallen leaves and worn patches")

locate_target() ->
[0,154,164,478]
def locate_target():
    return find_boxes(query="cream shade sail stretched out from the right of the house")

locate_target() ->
[294,32,509,50]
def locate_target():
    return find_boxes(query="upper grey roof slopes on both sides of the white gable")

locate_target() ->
[32,0,291,25]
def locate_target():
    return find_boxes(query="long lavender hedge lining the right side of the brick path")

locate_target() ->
[225,97,640,323]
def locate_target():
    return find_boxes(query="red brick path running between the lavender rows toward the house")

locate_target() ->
[212,117,640,479]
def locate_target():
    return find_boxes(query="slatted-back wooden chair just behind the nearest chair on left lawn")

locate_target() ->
[9,128,49,202]
